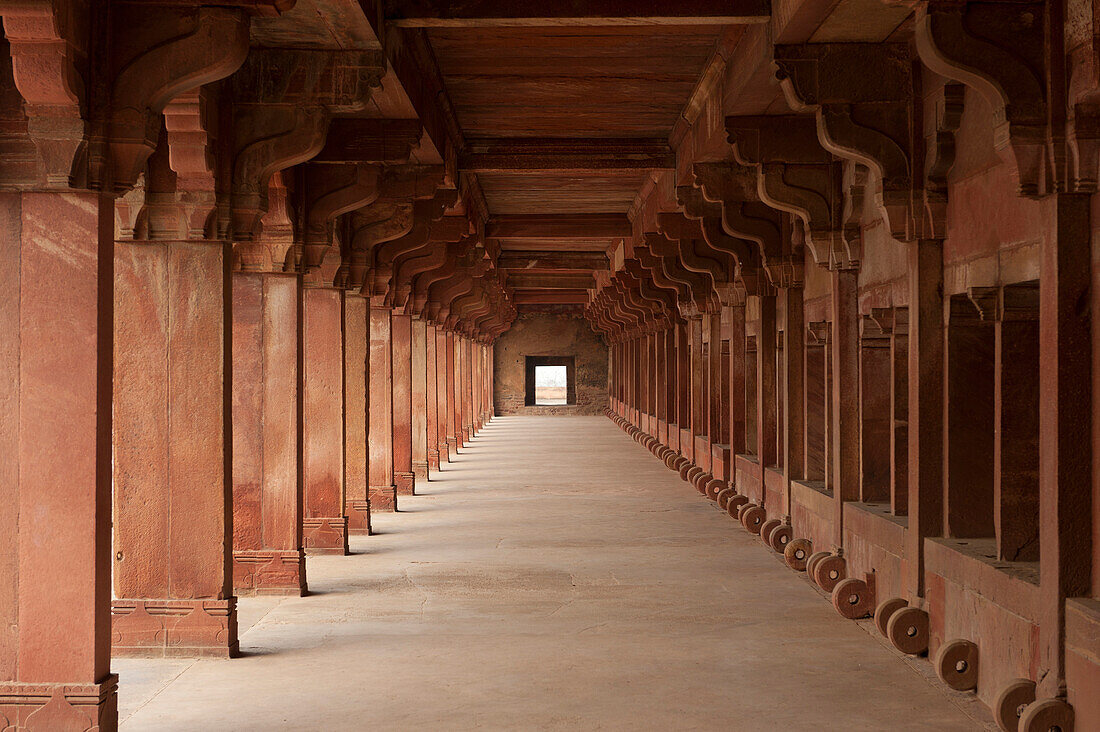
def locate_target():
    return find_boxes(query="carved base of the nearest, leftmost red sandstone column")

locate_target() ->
[0,674,119,732]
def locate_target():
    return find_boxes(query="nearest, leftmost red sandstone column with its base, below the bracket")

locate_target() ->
[0,190,118,730]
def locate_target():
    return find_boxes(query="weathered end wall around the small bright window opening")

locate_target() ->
[493,314,607,415]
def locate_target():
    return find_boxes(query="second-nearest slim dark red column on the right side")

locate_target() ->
[905,239,944,601]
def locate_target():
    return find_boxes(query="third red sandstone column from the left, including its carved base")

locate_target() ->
[232,272,306,596]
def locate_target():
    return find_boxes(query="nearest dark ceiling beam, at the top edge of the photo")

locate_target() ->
[385,0,771,28]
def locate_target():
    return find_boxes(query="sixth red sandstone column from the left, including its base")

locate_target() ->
[367,304,397,511]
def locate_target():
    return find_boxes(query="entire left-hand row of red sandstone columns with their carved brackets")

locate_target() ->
[0,0,503,730]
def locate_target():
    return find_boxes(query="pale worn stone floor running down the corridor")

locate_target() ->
[114,417,989,732]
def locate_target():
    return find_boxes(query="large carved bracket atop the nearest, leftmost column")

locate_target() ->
[2,0,258,194]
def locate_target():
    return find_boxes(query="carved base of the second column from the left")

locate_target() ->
[111,598,238,658]
